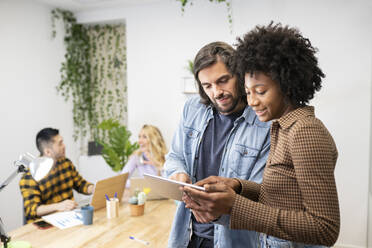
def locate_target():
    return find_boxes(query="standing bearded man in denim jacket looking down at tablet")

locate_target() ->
[164,42,270,248]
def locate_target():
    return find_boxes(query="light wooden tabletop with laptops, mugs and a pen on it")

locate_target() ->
[8,200,176,248]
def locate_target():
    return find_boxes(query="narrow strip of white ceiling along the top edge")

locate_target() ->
[36,0,169,11]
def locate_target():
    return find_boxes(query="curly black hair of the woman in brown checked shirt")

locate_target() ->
[236,22,325,106]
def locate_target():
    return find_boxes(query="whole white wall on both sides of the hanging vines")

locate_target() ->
[0,0,372,247]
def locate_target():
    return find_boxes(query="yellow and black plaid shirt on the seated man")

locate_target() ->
[19,158,91,223]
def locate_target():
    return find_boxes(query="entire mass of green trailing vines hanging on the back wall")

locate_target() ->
[52,9,127,145]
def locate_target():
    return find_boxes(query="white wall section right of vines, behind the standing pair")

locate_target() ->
[77,0,372,247]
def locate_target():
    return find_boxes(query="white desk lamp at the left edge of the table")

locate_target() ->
[0,153,54,248]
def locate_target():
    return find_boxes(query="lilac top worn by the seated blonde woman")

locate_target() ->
[122,153,158,188]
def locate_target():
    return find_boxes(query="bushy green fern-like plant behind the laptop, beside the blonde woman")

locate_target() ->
[95,119,139,171]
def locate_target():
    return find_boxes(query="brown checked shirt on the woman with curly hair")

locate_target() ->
[230,106,340,246]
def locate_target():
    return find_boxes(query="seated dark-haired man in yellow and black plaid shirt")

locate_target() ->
[19,128,94,223]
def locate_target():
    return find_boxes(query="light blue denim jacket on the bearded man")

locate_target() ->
[164,97,270,248]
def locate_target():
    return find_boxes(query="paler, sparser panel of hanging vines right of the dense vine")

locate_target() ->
[88,24,127,142]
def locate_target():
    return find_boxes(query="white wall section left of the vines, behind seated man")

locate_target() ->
[0,0,78,231]
